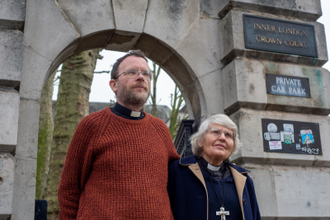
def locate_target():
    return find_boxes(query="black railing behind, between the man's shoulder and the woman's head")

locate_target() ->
[174,119,194,157]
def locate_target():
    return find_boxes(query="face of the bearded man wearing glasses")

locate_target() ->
[110,56,150,111]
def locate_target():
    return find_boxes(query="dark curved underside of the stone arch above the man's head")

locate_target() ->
[44,30,201,119]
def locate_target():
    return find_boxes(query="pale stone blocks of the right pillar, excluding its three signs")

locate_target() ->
[219,0,330,220]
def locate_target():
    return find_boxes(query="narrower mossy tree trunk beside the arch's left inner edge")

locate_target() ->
[36,69,57,199]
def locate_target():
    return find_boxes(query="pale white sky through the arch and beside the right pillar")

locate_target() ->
[53,0,330,107]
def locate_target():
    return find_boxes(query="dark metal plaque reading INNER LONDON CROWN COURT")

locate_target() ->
[243,15,317,58]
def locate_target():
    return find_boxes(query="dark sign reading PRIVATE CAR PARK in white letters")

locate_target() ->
[266,73,311,98]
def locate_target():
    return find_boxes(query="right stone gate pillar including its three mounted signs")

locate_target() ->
[219,0,330,220]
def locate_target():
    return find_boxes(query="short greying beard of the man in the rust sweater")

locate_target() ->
[117,85,150,105]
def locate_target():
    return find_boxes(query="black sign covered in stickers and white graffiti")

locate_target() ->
[261,119,322,155]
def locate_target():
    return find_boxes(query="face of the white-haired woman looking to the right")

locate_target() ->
[199,124,234,166]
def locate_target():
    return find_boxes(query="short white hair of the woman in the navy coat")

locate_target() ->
[190,114,241,157]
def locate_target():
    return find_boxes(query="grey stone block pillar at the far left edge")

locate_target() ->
[0,0,25,219]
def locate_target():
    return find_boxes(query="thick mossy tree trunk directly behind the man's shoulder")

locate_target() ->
[45,49,101,220]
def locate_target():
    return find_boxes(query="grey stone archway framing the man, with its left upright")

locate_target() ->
[8,0,223,219]
